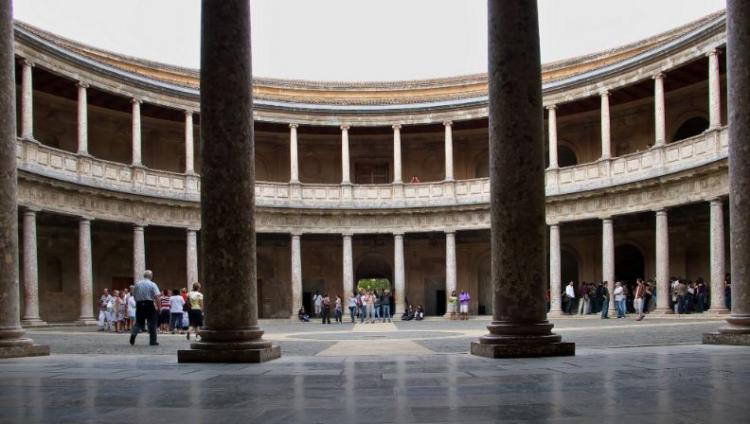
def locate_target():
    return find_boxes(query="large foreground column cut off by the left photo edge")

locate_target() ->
[0,0,49,358]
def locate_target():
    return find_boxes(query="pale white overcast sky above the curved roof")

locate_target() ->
[13,0,725,81]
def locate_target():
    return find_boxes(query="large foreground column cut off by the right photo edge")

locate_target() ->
[703,0,750,345]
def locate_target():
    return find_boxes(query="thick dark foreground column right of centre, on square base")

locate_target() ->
[471,0,575,358]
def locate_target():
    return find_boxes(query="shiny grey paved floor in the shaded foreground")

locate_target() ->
[0,341,750,424]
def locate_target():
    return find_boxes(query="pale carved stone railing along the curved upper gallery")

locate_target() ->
[17,128,728,209]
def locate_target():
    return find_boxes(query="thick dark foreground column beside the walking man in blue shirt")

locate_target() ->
[177,0,281,362]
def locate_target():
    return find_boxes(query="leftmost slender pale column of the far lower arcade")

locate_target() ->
[21,209,47,326]
